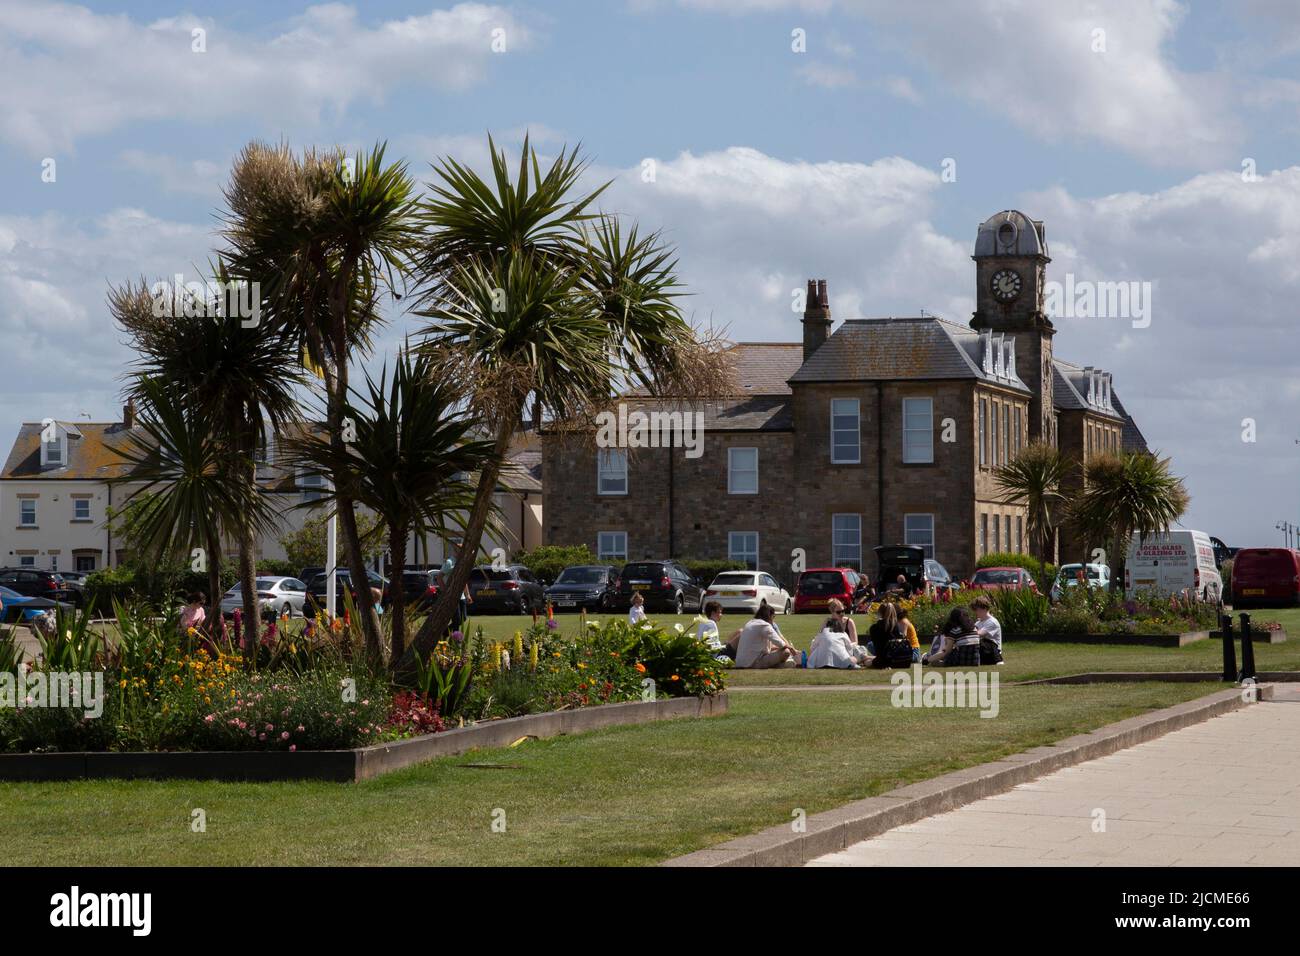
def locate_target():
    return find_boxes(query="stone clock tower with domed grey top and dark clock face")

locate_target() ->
[971,209,1056,444]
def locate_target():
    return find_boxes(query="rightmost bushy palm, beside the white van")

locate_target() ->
[1070,451,1191,589]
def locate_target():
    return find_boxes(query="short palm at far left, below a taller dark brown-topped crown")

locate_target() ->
[117,376,284,624]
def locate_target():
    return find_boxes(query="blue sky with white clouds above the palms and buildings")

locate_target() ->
[0,0,1300,546]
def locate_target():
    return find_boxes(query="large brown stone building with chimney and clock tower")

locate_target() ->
[542,211,1145,584]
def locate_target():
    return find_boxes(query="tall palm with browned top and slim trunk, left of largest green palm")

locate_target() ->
[224,143,416,659]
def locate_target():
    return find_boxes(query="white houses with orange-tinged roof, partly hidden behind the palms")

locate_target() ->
[0,406,542,571]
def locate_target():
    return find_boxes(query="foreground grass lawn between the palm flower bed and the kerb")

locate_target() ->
[0,684,1210,866]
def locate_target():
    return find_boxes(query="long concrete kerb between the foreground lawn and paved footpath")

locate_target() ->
[660,684,1273,866]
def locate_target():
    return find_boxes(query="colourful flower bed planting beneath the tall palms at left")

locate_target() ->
[0,607,725,753]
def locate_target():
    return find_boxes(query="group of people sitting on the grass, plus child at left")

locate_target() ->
[628,594,1002,670]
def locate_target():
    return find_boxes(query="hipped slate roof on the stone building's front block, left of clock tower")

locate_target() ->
[790,316,1028,393]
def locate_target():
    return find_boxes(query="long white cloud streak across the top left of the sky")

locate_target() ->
[0,0,533,155]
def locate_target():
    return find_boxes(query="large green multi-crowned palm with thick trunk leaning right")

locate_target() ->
[415,139,731,671]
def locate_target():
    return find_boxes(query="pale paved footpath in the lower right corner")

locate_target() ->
[809,685,1300,866]
